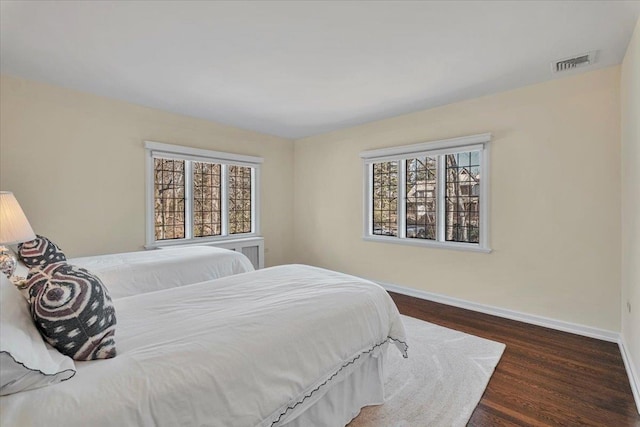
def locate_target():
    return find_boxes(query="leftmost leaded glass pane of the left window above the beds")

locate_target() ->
[153,158,185,240]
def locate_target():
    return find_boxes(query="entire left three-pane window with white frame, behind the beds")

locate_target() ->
[145,141,262,247]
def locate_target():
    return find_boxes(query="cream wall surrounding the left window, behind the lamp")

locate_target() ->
[0,76,293,265]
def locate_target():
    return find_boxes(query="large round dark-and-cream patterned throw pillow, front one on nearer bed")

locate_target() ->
[26,262,116,360]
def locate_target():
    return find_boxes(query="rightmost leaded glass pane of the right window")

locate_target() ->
[444,151,481,243]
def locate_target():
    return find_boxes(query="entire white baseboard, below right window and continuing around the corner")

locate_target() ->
[372,280,640,413]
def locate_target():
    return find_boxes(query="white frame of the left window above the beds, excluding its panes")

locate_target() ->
[144,141,264,249]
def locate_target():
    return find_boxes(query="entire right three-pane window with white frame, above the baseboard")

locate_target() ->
[360,134,491,252]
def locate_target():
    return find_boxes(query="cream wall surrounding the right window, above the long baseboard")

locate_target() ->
[294,67,620,331]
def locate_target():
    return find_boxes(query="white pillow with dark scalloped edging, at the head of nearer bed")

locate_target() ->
[0,272,76,396]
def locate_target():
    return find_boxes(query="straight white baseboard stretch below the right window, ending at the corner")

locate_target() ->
[374,280,620,343]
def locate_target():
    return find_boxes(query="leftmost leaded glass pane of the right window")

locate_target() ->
[372,162,398,236]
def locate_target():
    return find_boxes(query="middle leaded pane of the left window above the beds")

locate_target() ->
[193,162,222,237]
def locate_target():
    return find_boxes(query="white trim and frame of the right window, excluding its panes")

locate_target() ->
[360,133,491,253]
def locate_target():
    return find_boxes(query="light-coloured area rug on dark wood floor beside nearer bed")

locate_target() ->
[348,316,505,427]
